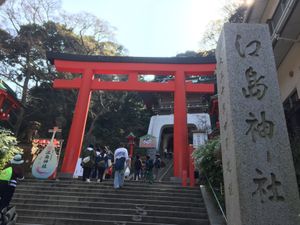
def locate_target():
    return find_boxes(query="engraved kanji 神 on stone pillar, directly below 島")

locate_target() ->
[246,111,274,142]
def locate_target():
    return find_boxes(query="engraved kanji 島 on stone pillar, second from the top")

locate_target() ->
[242,66,268,100]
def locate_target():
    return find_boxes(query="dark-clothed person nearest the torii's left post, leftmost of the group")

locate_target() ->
[81,145,96,183]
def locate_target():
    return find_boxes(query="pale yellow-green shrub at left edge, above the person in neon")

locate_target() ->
[0,127,23,170]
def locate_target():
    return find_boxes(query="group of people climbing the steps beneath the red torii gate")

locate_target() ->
[81,145,162,189]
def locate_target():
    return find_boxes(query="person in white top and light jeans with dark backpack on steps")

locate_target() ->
[114,145,129,189]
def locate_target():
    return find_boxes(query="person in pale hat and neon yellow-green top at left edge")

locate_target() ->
[0,154,24,212]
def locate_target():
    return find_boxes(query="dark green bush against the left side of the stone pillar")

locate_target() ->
[192,137,225,206]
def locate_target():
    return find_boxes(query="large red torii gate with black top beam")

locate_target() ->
[47,52,215,177]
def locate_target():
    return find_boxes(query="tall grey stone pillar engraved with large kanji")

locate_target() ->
[216,24,300,225]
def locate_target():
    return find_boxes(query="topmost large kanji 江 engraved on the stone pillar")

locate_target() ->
[235,34,261,58]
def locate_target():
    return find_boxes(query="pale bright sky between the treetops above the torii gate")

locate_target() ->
[62,0,228,57]
